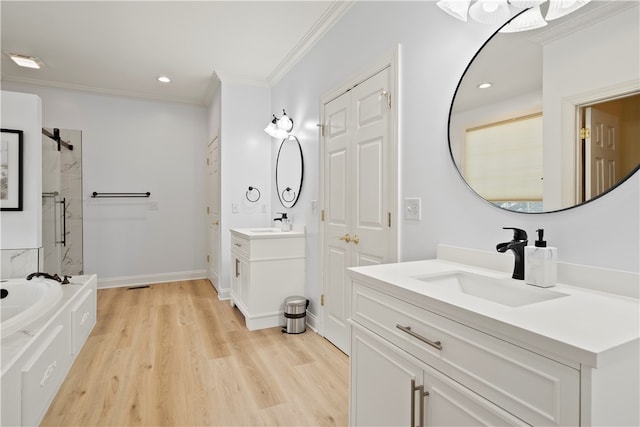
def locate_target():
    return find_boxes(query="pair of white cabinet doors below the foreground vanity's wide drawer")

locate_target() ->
[350,325,528,427]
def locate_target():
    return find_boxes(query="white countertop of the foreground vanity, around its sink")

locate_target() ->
[350,260,640,367]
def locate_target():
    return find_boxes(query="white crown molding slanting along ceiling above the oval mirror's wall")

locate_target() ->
[267,0,357,87]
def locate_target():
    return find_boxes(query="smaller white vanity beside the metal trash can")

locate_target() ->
[231,227,305,330]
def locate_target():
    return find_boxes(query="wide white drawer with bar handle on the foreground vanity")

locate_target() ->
[352,282,579,425]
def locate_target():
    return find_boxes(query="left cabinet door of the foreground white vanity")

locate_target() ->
[349,326,422,427]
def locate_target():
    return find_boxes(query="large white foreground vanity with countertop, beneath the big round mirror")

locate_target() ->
[350,260,640,426]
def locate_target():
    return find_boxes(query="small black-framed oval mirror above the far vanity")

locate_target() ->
[276,135,304,208]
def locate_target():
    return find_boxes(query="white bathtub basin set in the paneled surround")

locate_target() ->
[0,278,62,338]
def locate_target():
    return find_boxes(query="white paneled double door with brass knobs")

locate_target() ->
[322,67,397,354]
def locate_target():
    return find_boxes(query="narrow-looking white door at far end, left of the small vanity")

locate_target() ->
[207,135,220,289]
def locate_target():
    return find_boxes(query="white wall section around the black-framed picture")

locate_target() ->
[0,91,42,250]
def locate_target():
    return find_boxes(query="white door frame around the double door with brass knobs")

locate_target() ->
[317,45,401,336]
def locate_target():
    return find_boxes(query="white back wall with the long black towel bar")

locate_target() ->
[3,82,207,284]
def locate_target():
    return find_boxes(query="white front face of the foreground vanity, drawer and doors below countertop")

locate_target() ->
[351,282,580,425]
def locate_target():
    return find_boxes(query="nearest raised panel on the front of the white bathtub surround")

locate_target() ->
[22,324,71,425]
